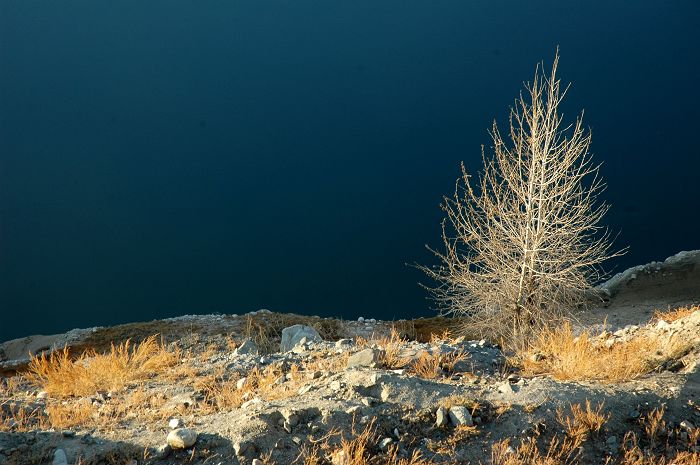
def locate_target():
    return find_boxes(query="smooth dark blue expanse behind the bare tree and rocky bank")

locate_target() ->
[0,0,700,340]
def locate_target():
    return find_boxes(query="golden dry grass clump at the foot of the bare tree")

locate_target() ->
[516,323,663,382]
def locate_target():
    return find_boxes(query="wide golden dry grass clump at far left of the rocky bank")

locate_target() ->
[26,336,180,398]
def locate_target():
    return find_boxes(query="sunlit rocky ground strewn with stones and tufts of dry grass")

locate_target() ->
[0,252,700,465]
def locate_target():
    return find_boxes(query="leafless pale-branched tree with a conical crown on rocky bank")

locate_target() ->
[419,52,619,344]
